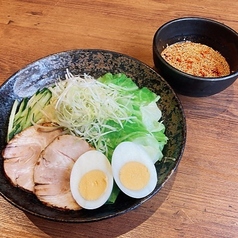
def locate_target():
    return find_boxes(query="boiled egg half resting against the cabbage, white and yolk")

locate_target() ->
[111,142,157,198]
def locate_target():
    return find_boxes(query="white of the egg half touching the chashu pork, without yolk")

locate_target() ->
[70,150,113,209]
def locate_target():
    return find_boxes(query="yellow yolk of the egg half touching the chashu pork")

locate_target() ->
[78,170,107,201]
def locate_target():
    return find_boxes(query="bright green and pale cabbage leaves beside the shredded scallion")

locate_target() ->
[98,73,168,163]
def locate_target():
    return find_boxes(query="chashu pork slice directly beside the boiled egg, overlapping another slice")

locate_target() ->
[34,135,93,210]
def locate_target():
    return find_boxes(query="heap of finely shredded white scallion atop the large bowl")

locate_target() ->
[46,71,133,152]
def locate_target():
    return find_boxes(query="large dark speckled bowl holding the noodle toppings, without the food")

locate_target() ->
[0,50,186,222]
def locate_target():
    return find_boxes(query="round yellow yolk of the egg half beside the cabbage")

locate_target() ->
[119,161,150,190]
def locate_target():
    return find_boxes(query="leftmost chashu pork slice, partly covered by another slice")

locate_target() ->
[2,123,62,192]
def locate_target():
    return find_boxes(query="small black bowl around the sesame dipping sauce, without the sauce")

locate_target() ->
[153,17,238,97]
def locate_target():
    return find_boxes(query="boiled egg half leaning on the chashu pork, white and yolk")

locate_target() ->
[70,150,113,209]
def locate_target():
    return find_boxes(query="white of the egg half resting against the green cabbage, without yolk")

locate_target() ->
[111,142,157,198]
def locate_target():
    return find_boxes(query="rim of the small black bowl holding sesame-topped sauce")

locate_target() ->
[153,17,238,82]
